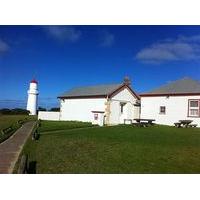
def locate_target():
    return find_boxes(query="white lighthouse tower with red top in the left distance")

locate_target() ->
[27,79,39,115]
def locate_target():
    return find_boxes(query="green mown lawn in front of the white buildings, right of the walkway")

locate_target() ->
[15,122,200,173]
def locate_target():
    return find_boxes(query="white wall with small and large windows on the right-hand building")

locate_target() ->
[141,96,200,127]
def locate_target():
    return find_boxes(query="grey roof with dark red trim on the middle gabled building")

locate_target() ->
[58,84,139,98]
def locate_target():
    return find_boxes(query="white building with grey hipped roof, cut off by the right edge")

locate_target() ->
[140,78,200,126]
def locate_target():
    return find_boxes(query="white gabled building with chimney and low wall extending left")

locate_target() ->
[42,79,140,125]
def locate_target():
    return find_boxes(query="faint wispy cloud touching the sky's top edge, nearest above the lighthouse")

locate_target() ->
[45,26,81,42]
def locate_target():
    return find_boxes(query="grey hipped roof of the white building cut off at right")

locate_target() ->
[140,78,200,96]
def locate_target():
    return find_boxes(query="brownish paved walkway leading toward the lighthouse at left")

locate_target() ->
[0,121,36,174]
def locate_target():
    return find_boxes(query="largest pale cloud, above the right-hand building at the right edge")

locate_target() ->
[135,35,200,63]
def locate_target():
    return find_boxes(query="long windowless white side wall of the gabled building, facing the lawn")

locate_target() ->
[60,98,106,122]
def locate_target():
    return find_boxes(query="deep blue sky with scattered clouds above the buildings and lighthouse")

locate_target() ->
[0,26,200,108]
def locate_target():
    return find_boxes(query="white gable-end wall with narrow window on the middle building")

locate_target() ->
[110,88,139,124]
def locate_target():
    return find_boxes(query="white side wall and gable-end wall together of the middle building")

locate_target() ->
[60,88,139,125]
